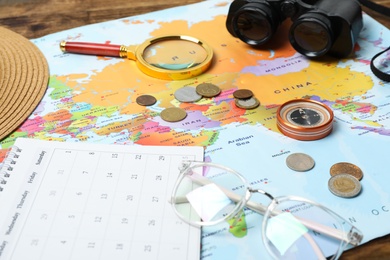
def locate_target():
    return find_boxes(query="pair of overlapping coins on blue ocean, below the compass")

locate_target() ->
[328,162,363,198]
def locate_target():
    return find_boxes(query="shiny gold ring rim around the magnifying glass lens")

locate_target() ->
[132,35,213,80]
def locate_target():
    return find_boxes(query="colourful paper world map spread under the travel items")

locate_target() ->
[0,0,390,259]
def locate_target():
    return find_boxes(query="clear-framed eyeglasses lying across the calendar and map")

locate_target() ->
[171,162,363,259]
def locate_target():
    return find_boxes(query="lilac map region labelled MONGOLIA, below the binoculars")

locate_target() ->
[241,54,309,76]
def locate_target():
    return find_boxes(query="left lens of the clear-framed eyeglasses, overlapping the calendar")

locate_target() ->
[173,166,246,225]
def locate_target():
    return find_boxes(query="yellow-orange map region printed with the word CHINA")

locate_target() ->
[236,61,373,105]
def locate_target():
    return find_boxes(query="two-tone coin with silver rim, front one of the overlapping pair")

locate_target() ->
[328,173,362,198]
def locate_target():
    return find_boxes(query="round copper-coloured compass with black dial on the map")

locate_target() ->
[277,99,333,141]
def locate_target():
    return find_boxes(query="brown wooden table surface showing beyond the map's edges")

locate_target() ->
[0,0,390,259]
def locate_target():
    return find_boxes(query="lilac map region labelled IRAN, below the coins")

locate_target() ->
[155,111,221,130]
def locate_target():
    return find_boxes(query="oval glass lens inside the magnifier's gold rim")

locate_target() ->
[143,39,207,70]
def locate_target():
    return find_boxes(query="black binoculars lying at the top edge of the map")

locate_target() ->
[226,0,363,58]
